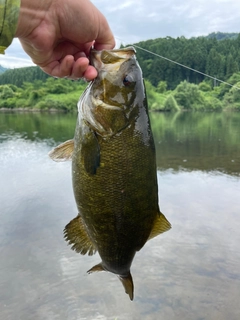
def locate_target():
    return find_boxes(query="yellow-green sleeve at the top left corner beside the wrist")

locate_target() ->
[0,0,20,54]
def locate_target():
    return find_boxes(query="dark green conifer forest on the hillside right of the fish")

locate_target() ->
[132,34,240,89]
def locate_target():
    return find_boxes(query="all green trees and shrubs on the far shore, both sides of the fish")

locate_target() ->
[0,32,240,111]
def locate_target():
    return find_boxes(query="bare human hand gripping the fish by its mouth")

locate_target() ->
[15,0,115,81]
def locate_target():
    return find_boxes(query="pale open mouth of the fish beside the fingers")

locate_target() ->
[90,46,136,70]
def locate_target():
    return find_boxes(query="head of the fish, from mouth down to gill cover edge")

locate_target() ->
[78,47,146,136]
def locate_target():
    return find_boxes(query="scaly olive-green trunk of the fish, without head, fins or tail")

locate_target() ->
[72,104,159,275]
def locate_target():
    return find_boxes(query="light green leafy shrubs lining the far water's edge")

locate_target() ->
[0,73,240,112]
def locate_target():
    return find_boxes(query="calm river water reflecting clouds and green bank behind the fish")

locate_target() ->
[0,113,240,320]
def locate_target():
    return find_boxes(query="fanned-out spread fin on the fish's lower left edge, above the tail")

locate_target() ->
[64,215,97,256]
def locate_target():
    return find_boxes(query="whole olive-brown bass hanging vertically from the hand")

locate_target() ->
[50,47,171,300]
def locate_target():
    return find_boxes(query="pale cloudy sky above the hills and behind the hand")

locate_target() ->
[0,0,240,67]
